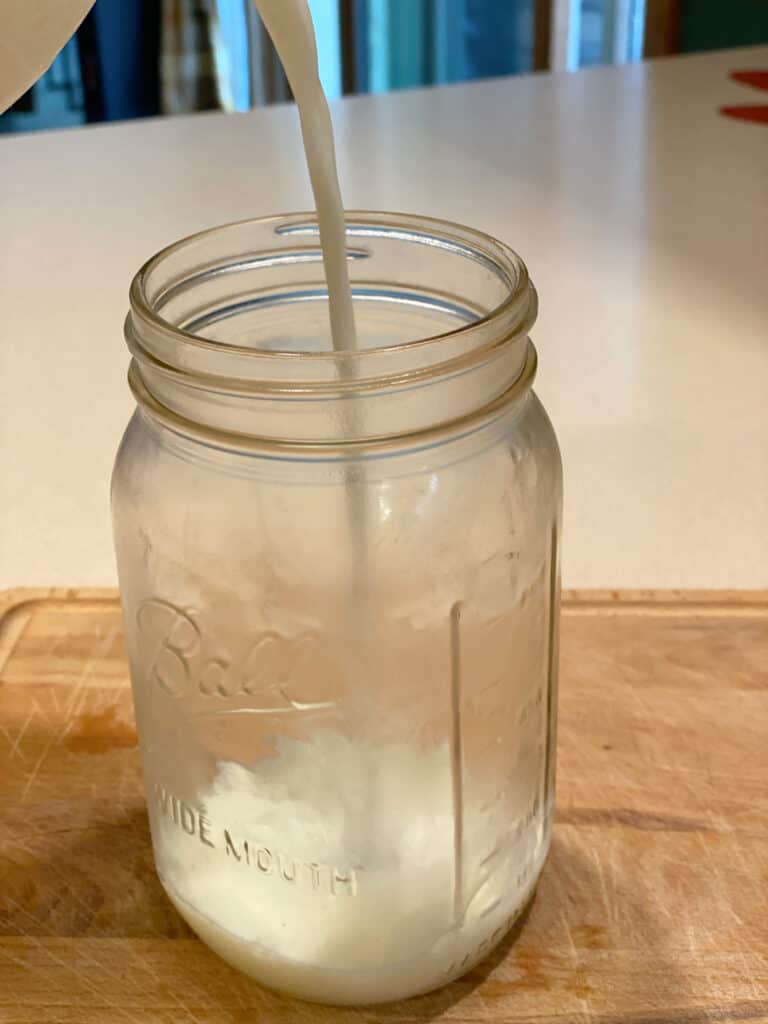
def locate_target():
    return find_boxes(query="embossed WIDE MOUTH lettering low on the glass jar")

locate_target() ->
[155,783,357,896]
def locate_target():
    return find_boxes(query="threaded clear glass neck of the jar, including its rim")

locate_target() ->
[125,213,537,449]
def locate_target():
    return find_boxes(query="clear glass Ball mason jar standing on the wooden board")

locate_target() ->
[113,213,561,1004]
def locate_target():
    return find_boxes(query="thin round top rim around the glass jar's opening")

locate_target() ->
[129,210,536,376]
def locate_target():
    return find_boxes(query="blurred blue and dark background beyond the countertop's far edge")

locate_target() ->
[0,0,768,132]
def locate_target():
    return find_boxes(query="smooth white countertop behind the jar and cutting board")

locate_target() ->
[0,47,768,588]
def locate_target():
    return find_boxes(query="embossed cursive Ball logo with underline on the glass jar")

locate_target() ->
[136,598,334,715]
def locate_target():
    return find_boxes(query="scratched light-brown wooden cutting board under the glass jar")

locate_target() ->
[0,590,768,1024]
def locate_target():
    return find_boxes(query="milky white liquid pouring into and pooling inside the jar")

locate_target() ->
[156,0,546,1004]
